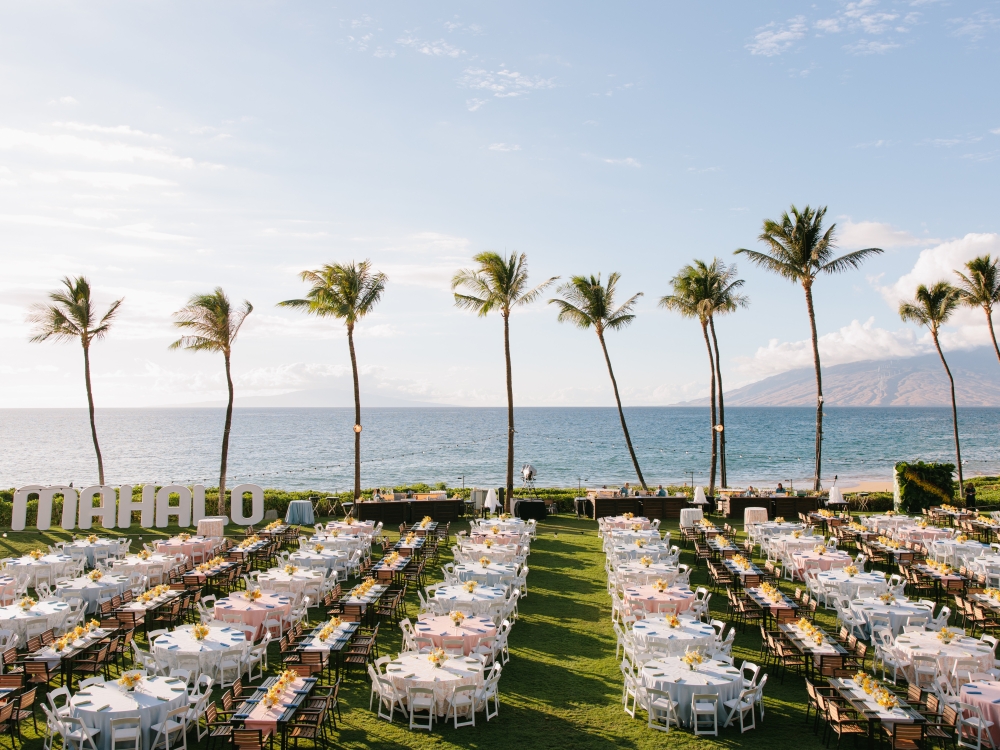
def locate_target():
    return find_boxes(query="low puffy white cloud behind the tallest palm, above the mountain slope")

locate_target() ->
[737,317,929,380]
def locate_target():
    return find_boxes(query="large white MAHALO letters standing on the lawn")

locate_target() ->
[10,484,264,531]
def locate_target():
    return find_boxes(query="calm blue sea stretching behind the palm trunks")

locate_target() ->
[0,408,1000,491]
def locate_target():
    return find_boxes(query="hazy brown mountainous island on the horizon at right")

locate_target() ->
[673,347,1000,406]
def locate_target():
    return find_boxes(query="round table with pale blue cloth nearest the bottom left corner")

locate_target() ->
[69,675,188,750]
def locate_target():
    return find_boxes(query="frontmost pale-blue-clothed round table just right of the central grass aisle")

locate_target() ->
[640,656,743,727]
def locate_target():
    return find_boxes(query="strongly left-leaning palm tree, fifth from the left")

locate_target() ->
[549,273,648,490]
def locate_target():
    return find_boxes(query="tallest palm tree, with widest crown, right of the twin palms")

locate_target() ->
[736,206,882,491]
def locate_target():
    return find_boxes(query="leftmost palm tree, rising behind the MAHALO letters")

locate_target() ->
[28,276,124,485]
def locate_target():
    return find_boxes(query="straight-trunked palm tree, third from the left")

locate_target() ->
[278,260,388,500]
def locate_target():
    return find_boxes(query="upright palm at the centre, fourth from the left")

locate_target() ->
[451,250,559,510]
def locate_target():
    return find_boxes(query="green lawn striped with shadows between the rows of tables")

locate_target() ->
[0,516,833,750]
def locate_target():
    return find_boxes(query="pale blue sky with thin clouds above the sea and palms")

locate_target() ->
[0,0,1000,407]
